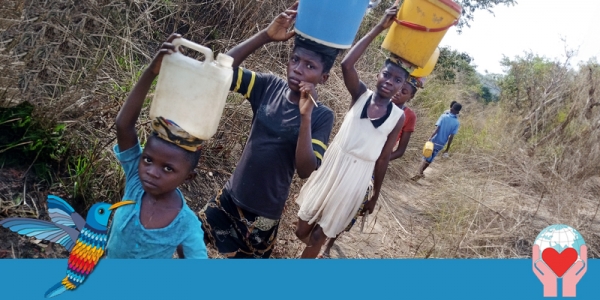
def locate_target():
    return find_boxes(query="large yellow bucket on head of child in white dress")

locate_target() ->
[381,0,462,68]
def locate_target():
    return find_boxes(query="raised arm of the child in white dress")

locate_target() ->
[342,6,398,107]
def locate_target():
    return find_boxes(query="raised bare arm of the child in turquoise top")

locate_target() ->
[115,34,180,152]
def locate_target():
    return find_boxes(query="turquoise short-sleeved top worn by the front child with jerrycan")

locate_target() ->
[106,143,208,259]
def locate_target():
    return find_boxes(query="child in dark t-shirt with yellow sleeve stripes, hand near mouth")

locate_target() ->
[199,3,339,258]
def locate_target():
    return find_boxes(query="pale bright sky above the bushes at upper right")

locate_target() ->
[440,0,600,74]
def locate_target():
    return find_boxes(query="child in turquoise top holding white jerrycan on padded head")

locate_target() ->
[106,35,208,259]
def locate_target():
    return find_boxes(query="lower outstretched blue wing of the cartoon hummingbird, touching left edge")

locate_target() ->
[0,218,79,252]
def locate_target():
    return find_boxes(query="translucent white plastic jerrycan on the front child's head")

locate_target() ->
[150,38,233,140]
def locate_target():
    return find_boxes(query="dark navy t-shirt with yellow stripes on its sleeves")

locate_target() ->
[225,68,334,219]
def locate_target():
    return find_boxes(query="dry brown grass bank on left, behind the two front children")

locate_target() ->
[0,0,382,256]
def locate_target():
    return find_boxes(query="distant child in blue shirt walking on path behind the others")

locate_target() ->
[412,102,462,180]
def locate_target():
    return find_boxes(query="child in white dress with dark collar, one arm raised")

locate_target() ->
[296,7,409,258]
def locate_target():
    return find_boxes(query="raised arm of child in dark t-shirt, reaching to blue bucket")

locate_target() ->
[227,1,298,70]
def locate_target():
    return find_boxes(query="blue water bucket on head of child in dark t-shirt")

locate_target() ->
[294,0,369,49]
